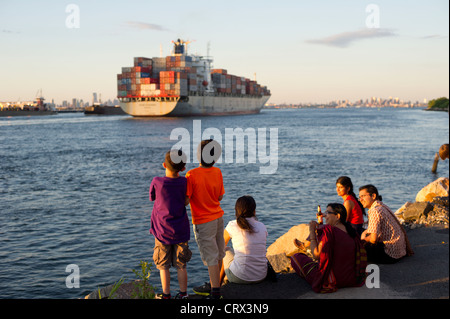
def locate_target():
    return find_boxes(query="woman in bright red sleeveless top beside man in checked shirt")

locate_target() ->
[336,176,365,236]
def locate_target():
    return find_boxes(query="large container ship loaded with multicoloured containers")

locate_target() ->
[117,39,271,117]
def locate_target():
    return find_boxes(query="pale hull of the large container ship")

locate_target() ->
[120,95,270,117]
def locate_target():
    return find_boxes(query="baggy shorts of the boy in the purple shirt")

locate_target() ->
[153,238,192,270]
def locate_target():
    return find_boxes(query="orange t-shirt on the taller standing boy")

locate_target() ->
[186,166,225,225]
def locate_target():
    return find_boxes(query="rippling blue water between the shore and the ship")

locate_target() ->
[0,109,449,298]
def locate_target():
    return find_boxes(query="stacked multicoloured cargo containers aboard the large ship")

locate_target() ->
[117,55,270,98]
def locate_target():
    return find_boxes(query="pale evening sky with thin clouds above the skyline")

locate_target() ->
[0,0,449,104]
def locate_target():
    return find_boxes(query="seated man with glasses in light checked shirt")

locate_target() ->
[359,185,414,264]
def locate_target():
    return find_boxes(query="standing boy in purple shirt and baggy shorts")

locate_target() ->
[150,150,192,299]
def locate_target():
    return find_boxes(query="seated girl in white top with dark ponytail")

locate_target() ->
[221,196,267,284]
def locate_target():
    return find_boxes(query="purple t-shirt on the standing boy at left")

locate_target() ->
[150,176,191,245]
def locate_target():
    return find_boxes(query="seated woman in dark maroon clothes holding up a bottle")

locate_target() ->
[291,203,367,293]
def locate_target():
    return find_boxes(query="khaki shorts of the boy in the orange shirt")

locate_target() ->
[194,217,225,266]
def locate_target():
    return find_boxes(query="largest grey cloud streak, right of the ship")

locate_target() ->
[306,28,397,48]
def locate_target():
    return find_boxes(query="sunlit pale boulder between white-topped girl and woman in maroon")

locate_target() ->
[267,224,309,272]
